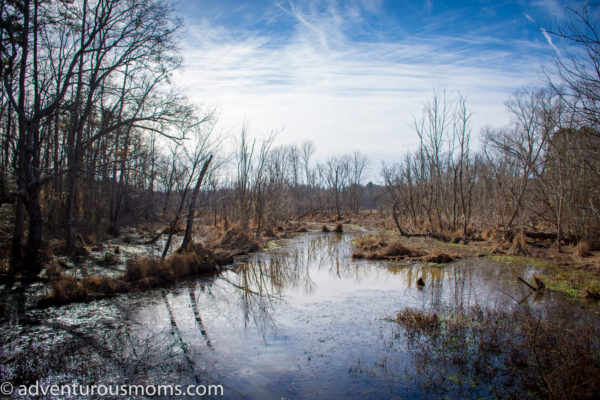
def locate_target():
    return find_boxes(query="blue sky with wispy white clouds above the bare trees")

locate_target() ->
[175,0,573,177]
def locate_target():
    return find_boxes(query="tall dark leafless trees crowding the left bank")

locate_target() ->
[0,0,203,273]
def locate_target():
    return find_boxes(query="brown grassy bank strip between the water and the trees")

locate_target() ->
[0,211,600,314]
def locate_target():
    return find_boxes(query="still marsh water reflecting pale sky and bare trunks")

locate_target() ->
[0,233,596,399]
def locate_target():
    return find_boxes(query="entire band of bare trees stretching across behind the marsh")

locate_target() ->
[0,0,600,274]
